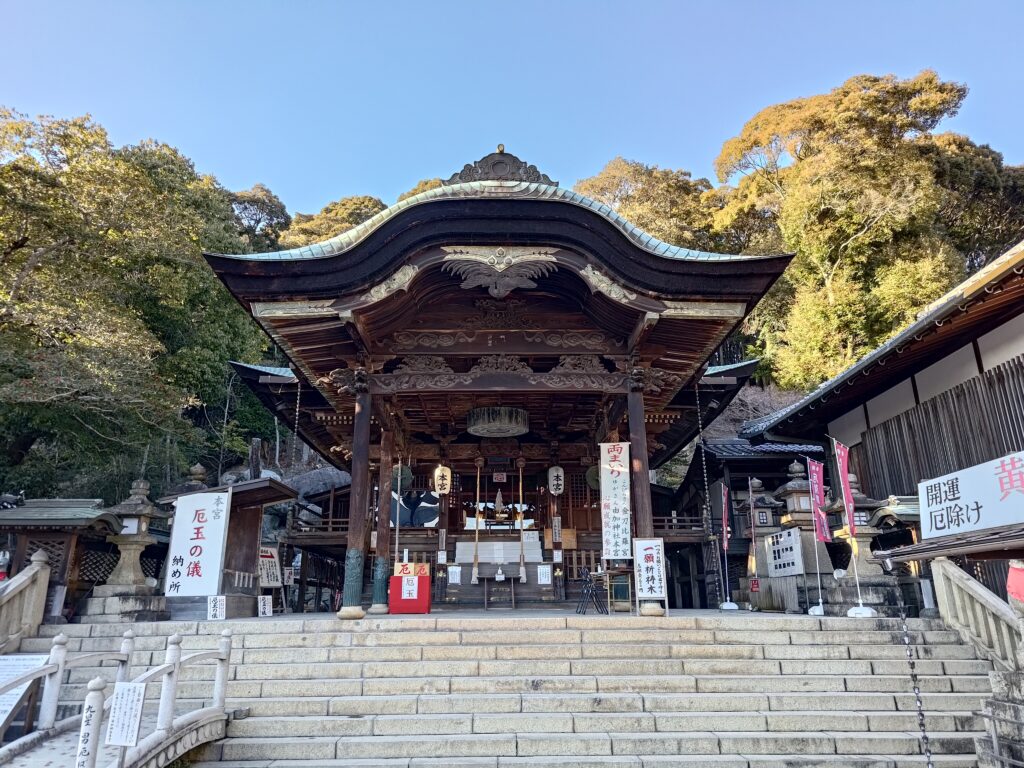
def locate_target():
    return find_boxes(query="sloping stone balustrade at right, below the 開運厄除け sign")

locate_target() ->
[932,557,1022,671]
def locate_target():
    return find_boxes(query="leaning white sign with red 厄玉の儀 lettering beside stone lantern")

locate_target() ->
[164,488,231,597]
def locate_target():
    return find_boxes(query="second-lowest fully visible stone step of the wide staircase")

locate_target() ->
[227,710,984,738]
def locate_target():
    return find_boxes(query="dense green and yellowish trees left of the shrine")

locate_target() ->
[0,110,272,499]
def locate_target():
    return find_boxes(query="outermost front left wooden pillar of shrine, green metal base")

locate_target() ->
[338,368,370,618]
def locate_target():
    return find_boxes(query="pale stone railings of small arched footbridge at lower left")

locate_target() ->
[0,630,231,768]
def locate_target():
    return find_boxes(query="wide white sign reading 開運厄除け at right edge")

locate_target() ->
[918,452,1024,539]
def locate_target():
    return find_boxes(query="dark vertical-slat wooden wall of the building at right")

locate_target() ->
[859,357,1024,499]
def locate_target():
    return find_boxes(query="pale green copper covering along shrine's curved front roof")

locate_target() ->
[211,179,779,268]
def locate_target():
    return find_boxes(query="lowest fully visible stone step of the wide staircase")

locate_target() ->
[203,731,980,765]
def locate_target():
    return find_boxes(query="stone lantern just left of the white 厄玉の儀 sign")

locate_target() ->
[82,480,171,624]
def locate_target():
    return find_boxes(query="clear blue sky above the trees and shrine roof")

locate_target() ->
[8,0,1024,212]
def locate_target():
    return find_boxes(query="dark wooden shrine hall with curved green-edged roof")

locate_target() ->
[207,147,791,617]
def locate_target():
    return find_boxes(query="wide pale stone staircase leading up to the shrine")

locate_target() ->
[22,611,990,768]
